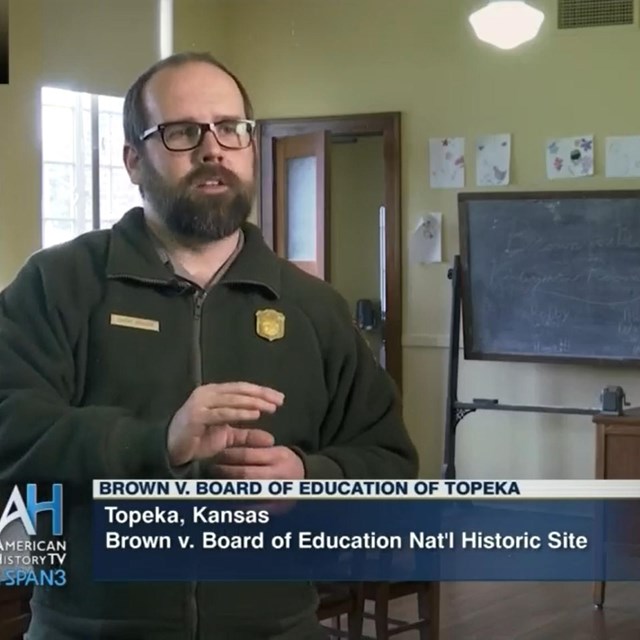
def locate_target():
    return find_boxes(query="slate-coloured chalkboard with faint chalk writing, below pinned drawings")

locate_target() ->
[458,191,640,364]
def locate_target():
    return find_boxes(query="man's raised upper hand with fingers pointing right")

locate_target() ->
[167,382,284,466]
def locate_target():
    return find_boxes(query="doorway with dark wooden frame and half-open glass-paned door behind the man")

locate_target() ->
[258,112,402,391]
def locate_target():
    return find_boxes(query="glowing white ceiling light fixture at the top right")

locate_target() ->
[469,0,544,49]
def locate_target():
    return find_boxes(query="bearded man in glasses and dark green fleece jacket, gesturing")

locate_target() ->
[0,53,418,640]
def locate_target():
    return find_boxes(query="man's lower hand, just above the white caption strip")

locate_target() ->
[211,445,304,480]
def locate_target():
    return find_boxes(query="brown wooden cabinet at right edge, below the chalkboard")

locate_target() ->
[593,407,640,607]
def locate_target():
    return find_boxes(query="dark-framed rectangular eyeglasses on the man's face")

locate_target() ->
[140,120,256,151]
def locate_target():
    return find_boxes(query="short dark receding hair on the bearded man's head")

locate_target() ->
[122,51,253,149]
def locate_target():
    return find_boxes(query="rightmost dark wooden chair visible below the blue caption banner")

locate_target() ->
[364,582,440,640]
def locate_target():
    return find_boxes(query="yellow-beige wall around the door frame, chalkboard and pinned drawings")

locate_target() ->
[212,0,640,478]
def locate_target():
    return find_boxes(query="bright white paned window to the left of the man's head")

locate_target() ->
[41,87,141,247]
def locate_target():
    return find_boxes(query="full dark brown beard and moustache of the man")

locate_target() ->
[141,159,255,243]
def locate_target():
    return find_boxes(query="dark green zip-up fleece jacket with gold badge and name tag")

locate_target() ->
[0,209,417,640]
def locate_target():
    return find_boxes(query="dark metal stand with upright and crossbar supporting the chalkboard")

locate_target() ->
[442,256,602,480]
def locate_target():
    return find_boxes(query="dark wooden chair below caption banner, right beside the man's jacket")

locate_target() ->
[316,582,364,640]
